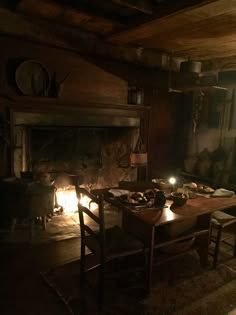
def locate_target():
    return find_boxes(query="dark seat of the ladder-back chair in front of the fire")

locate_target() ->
[85,226,144,260]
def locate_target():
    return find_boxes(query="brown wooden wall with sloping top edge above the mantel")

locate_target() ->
[0,38,128,104]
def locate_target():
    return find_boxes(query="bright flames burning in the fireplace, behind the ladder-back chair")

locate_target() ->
[56,186,97,213]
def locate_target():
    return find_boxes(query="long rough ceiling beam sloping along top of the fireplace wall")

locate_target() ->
[0,9,183,70]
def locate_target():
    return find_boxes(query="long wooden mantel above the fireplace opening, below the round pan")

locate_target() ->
[0,96,150,127]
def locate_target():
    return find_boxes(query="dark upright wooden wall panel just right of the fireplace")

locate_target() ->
[146,89,191,178]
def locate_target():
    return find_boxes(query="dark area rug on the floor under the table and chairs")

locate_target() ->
[42,252,236,315]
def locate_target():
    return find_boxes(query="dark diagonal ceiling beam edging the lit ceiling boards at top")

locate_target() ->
[109,0,217,43]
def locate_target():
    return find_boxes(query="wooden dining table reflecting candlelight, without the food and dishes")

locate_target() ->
[93,189,236,291]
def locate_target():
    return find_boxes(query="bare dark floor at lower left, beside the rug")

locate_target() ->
[0,238,80,315]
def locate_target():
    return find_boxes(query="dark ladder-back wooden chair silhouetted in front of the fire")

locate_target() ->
[76,187,145,309]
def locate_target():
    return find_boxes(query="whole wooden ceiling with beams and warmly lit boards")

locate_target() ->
[0,0,236,60]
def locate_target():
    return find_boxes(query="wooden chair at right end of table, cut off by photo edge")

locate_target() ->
[209,211,236,268]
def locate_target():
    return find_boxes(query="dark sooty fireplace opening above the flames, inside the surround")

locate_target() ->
[30,127,139,188]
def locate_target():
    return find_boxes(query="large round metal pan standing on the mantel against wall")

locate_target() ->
[15,60,51,96]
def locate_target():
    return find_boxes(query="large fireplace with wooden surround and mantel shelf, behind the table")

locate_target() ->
[13,103,147,214]
